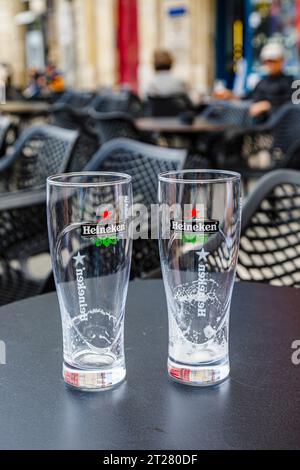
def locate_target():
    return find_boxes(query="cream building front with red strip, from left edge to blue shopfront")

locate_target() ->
[0,0,215,91]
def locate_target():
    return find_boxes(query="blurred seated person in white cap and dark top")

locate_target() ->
[247,42,294,121]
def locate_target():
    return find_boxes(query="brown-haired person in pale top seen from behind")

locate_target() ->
[146,50,188,97]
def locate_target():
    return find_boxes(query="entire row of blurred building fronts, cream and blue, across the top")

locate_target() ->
[0,0,300,92]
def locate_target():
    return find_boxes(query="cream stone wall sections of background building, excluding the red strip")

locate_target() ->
[0,0,215,92]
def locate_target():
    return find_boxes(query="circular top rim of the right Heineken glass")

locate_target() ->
[158,169,241,184]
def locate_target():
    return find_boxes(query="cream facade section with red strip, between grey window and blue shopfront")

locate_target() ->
[53,0,215,92]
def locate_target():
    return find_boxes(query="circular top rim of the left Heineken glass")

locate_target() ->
[47,171,132,188]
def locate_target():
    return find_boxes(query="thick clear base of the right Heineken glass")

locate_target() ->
[168,357,230,387]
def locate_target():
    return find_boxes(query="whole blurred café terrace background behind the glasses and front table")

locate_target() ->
[0,0,300,304]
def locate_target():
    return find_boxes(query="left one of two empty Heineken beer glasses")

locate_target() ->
[47,172,132,390]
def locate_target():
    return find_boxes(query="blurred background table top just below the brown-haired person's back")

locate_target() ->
[135,117,232,134]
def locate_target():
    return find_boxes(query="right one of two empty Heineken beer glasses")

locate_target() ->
[158,170,241,385]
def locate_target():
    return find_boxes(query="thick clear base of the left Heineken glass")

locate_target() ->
[63,362,126,392]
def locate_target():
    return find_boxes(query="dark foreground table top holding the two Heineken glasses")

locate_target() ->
[0,280,300,450]
